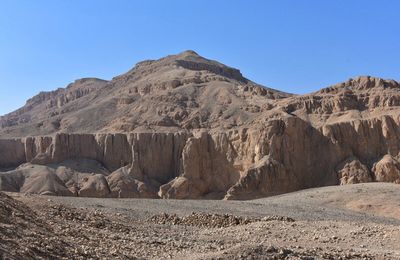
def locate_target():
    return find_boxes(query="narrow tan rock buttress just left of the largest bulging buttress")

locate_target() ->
[159,132,239,199]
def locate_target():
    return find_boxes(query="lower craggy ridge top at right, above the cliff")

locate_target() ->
[282,76,400,118]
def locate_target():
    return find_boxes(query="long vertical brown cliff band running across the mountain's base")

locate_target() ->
[0,108,400,199]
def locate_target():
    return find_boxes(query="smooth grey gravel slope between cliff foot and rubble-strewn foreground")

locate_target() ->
[41,183,400,224]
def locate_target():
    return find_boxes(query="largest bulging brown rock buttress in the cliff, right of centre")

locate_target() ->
[226,117,340,199]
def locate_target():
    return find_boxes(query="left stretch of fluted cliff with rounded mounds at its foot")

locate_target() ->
[0,133,192,197]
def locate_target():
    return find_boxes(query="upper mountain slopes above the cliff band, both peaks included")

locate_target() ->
[0,50,400,141]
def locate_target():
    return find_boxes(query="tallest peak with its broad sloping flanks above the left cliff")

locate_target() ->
[0,51,289,137]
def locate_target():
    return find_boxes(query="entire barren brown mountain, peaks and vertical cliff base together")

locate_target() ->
[0,51,400,199]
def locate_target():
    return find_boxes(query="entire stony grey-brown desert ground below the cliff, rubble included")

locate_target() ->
[0,183,400,259]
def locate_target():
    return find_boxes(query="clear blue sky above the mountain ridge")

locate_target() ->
[0,0,400,115]
